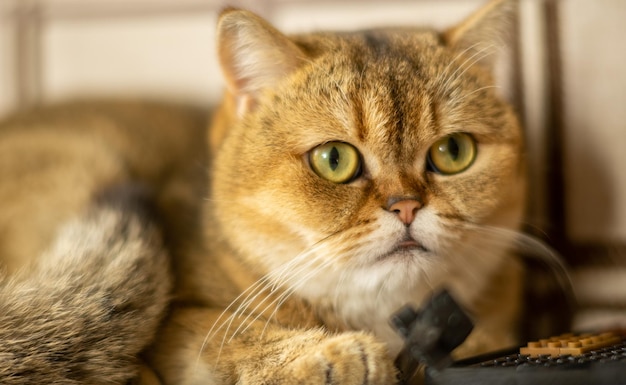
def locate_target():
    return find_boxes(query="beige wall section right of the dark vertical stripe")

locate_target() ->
[561,0,626,242]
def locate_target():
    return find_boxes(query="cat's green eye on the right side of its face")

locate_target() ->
[428,133,476,175]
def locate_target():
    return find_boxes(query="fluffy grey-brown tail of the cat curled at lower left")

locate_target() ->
[0,196,170,384]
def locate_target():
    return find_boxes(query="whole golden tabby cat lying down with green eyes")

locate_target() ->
[0,0,525,385]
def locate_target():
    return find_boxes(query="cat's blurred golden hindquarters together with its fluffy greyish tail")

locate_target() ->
[0,103,205,385]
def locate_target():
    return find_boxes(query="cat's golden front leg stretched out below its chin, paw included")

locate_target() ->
[153,308,396,385]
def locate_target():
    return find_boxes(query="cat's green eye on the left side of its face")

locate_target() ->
[309,142,361,183]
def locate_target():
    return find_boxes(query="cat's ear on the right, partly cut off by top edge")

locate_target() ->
[443,0,518,67]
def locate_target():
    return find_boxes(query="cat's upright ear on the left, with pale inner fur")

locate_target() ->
[217,8,306,115]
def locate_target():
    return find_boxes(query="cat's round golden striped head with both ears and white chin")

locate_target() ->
[210,1,525,301]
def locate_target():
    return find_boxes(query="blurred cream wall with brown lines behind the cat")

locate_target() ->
[0,0,626,340]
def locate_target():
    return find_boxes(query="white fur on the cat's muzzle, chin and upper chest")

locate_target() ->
[297,210,446,357]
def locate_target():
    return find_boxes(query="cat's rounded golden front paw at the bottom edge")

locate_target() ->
[272,332,396,385]
